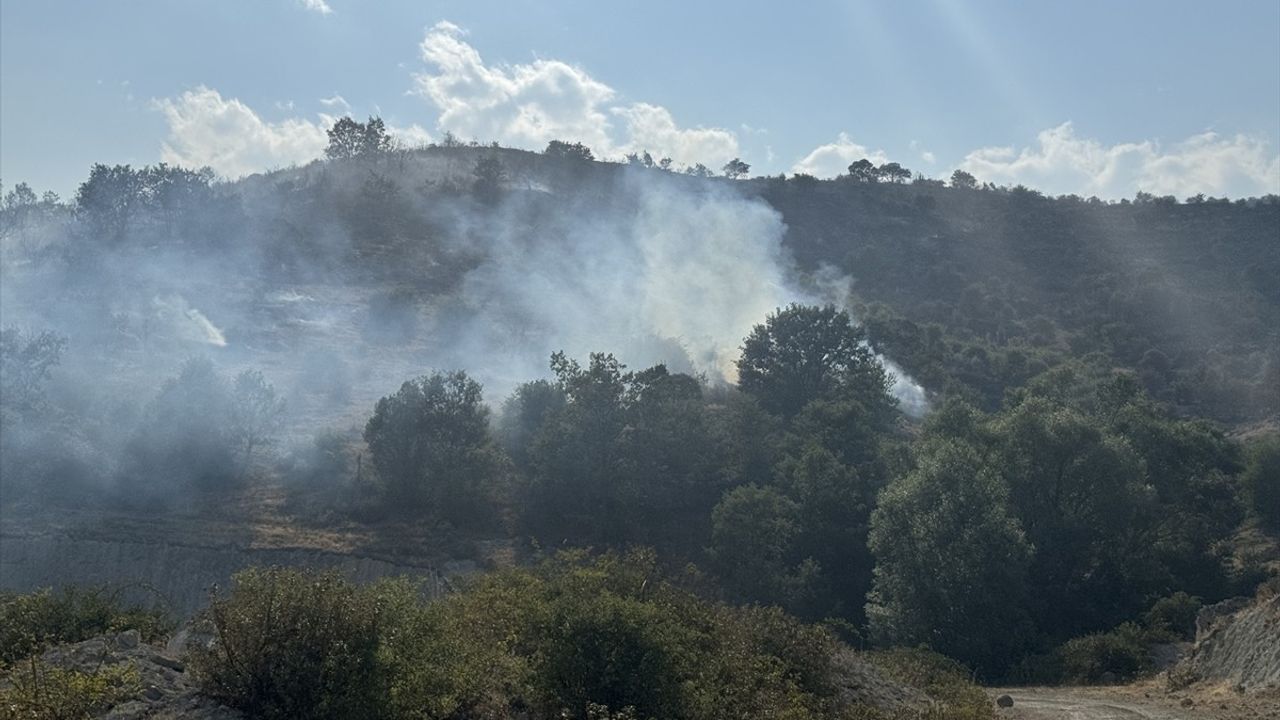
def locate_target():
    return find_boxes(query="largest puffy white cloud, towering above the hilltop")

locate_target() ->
[413,22,739,164]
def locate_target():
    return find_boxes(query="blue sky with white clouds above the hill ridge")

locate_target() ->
[0,0,1280,199]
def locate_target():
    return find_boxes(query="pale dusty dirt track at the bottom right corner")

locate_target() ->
[988,680,1280,720]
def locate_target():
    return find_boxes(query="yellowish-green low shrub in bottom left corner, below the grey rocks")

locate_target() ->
[0,659,142,720]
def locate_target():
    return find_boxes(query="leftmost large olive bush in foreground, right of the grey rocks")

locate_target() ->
[191,569,403,720]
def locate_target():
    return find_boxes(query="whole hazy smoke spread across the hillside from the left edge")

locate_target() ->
[0,149,925,504]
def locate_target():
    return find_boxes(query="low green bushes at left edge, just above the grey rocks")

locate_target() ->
[0,587,173,665]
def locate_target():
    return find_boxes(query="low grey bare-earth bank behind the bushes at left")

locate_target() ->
[0,533,475,618]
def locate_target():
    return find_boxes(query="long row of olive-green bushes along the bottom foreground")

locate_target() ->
[192,552,921,720]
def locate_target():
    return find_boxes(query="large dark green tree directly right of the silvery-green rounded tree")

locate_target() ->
[991,397,1167,639]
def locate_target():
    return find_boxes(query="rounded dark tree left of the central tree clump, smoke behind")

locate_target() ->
[365,372,500,521]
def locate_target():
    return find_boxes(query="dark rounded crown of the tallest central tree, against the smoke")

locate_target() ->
[737,305,892,418]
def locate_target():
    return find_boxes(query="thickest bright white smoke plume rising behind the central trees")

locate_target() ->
[440,170,928,415]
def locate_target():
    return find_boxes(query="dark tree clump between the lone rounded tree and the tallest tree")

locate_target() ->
[524,352,722,544]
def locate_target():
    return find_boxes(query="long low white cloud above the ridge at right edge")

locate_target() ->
[960,122,1280,197]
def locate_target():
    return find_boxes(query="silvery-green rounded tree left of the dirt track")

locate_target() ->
[867,441,1043,676]
